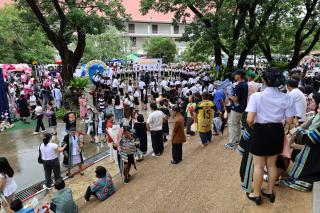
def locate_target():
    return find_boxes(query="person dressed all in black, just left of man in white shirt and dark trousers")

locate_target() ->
[134,114,148,154]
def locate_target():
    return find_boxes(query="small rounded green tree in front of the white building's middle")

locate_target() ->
[143,37,177,63]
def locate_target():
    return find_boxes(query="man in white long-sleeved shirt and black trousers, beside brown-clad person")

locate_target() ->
[147,102,165,157]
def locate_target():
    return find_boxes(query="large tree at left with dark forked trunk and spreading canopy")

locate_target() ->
[16,0,129,83]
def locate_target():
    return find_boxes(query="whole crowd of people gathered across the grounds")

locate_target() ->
[0,60,320,212]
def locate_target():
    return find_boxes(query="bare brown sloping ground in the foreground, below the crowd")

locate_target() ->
[77,133,312,213]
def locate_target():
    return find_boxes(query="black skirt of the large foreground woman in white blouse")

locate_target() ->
[250,123,284,156]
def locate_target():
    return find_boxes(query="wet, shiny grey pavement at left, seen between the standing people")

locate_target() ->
[0,106,172,192]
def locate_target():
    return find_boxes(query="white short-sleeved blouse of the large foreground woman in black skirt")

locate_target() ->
[246,87,296,124]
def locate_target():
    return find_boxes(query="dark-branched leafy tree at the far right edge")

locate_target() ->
[259,0,320,69]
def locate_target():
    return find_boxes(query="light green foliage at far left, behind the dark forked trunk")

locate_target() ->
[0,5,54,64]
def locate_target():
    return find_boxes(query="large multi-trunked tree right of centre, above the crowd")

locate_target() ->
[141,0,285,70]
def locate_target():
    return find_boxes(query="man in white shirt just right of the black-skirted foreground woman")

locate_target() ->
[287,79,307,124]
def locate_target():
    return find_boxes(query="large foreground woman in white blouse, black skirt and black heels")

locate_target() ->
[246,68,295,205]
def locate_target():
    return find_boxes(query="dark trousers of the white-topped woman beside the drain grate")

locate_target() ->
[43,158,61,188]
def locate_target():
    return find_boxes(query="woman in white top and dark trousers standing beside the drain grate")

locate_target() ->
[39,133,67,189]
